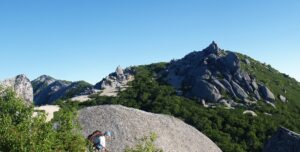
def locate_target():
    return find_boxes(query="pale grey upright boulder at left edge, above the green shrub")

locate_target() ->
[0,75,33,104]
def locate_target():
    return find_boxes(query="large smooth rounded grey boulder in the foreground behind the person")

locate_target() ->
[79,106,221,152]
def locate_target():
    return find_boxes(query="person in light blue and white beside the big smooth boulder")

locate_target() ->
[88,130,112,152]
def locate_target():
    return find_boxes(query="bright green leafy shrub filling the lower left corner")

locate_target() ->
[0,90,86,152]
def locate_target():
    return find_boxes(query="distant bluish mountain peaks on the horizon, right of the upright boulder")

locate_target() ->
[32,75,93,105]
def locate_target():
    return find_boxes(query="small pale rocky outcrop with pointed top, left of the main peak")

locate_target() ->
[95,66,134,96]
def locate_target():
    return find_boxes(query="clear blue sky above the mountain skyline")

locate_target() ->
[0,0,300,83]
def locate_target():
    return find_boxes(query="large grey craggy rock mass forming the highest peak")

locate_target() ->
[162,42,275,106]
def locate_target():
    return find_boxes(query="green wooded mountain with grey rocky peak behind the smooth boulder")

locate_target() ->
[1,42,300,152]
